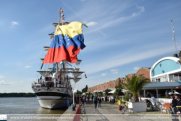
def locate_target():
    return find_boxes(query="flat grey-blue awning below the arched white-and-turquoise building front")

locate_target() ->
[143,81,181,90]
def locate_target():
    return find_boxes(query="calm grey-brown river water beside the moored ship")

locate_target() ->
[0,97,66,114]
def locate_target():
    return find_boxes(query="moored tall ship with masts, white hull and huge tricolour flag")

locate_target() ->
[32,9,85,109]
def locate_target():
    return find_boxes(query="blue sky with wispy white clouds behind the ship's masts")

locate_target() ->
[0,0,181,93]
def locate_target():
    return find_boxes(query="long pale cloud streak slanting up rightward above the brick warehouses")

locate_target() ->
[86,43,181,74]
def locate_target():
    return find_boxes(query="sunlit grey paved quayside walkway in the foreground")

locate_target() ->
[81,101,174,121]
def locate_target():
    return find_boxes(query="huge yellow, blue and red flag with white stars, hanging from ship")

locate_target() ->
[43,21,87,63]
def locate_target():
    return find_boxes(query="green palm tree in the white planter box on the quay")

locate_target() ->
[123,76,149,102]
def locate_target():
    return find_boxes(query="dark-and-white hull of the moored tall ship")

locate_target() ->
[33,88,73,109]
